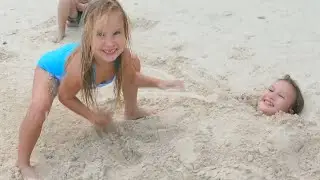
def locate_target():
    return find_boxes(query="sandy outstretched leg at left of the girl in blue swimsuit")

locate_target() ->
[17,67,58,179]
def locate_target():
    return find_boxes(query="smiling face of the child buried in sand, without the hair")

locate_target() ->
[258,80,296,116]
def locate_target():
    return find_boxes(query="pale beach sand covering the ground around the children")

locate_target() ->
[0,0,320,180]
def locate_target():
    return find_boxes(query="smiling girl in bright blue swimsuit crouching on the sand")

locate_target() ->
[17,0,183,178]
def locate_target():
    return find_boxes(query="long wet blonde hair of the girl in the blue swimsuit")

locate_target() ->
[75,0,130,106]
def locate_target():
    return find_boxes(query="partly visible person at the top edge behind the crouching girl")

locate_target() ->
[55,0,90,42]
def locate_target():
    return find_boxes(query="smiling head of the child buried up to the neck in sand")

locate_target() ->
[257,75,304,116]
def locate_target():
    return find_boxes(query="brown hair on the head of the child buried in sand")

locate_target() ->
[278,74,304,114]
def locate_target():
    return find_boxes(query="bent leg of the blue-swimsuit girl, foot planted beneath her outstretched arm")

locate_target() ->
[122,54,150,120]
